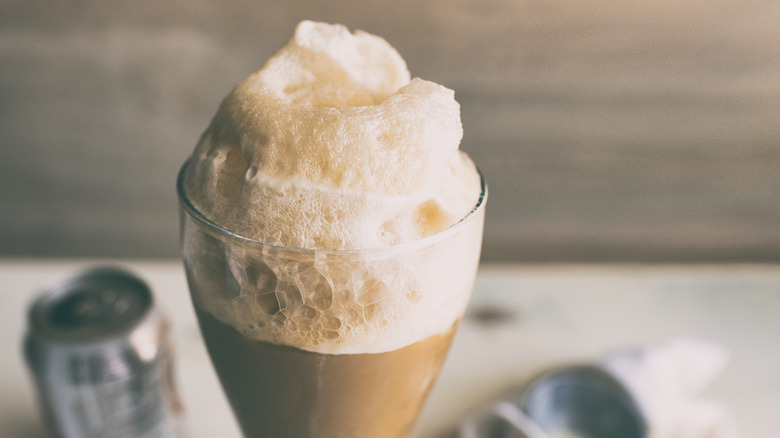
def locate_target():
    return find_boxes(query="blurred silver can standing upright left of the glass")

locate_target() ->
[24,268,182,438]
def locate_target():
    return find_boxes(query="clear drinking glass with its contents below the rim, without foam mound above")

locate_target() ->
[177,163,487,438]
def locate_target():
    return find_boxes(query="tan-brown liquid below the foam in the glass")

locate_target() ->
[196,306,455,438]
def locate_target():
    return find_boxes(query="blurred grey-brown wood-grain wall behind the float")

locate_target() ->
[0,0,780,262]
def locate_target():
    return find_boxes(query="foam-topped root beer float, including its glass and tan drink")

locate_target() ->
[178,21,486,438]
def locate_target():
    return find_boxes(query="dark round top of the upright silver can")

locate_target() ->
[29,267,153,344]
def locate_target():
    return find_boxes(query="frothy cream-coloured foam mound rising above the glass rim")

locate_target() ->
[185,21,479,249]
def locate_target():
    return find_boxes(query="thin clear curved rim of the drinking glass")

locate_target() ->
[176,158,488,254]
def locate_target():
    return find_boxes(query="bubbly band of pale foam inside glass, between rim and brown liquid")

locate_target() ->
[184,210,484,354]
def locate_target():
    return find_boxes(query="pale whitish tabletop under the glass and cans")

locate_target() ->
[0,259,780,438]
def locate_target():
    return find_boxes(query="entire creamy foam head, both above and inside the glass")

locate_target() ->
[180,21,488,352]
